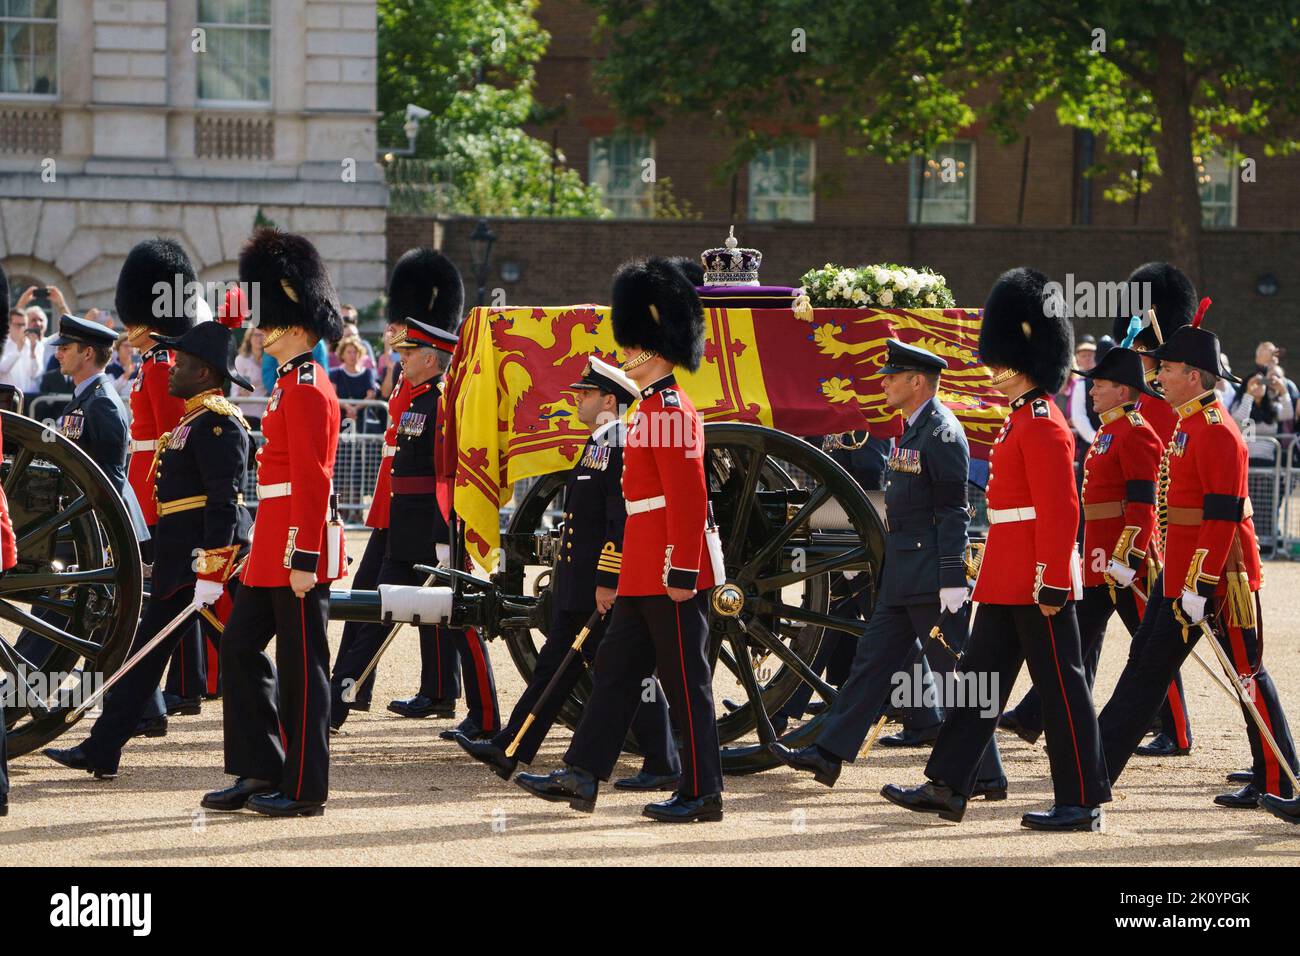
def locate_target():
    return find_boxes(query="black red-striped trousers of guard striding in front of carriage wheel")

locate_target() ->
[564,592,723,799]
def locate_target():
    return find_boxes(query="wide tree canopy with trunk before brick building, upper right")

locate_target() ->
[589,0,1300,277]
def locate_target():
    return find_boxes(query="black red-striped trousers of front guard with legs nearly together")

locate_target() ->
[221,581,329,801]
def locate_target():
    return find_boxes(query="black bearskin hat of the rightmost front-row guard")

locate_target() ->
[979,267,1074,393]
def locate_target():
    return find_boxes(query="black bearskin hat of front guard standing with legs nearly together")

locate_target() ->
[239,228,343,341]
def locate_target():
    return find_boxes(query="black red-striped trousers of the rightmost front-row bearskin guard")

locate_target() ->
[926,601,1107,806]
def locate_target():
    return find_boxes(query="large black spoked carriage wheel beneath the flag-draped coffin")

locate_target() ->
[501,423,884,774]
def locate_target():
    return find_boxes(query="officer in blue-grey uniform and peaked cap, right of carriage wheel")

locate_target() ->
[776,339,1006,800]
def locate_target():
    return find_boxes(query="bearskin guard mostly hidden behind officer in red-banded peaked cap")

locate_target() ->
[330,248,465,728]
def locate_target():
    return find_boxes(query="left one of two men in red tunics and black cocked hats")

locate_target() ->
[998,346,1165,753]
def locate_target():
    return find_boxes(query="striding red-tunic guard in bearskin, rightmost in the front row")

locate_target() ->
[881,268,1110,831]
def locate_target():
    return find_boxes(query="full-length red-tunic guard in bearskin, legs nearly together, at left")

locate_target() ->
[202,229,346,817]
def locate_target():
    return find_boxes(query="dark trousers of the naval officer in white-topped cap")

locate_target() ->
[493,609,681,774]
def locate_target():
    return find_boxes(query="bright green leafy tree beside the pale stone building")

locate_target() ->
[378,0,607,216]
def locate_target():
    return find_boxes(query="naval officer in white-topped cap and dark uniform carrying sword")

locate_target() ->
[456,356,681,791]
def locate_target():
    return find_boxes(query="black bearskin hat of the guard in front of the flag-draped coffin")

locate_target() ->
[610,258,705,372]
